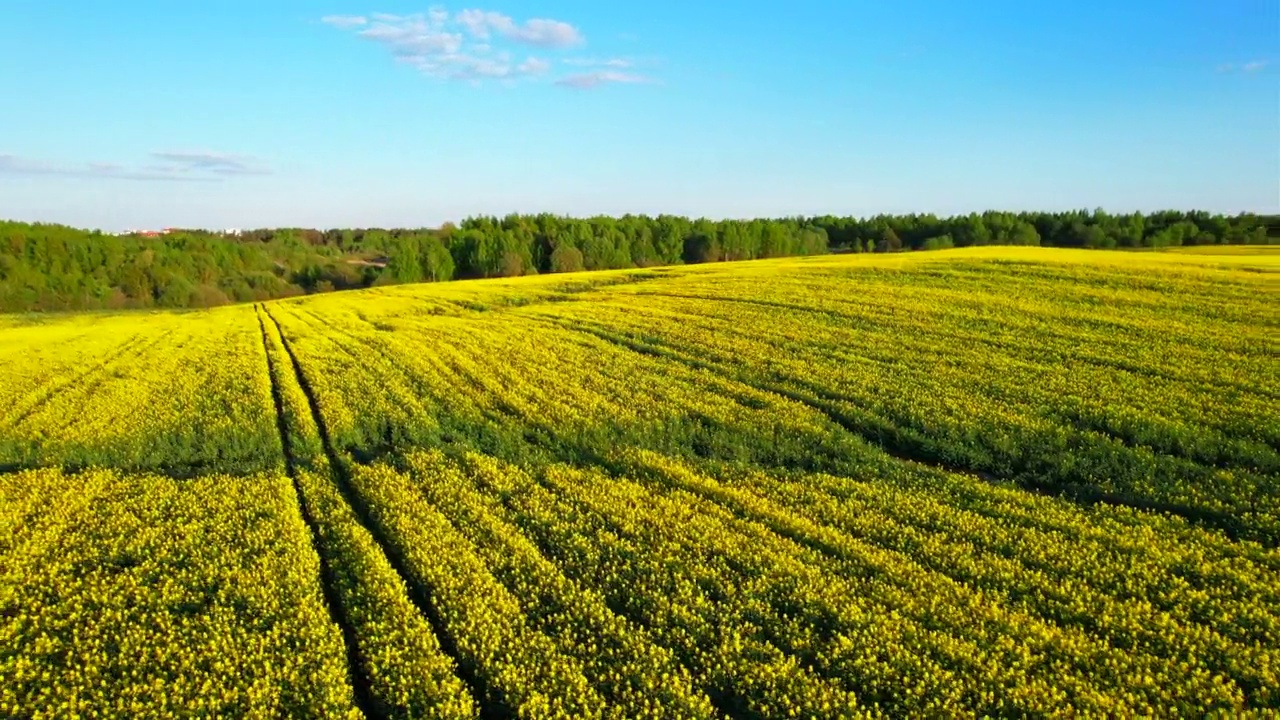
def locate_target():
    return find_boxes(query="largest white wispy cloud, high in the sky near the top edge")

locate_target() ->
[321,8,650,88]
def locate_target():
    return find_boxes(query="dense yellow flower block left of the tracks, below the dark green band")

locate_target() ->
[0,470,358,717]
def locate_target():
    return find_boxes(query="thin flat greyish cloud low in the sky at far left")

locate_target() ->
[0,152,270,182]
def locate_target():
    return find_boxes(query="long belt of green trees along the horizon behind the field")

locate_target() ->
[0,210,1280,313]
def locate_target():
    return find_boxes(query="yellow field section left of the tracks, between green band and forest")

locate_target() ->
[0,307,279,475]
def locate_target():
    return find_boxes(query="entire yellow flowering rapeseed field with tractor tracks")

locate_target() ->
[0,247,1280,717]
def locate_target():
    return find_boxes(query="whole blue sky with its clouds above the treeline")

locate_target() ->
[0,0,1280,229]
